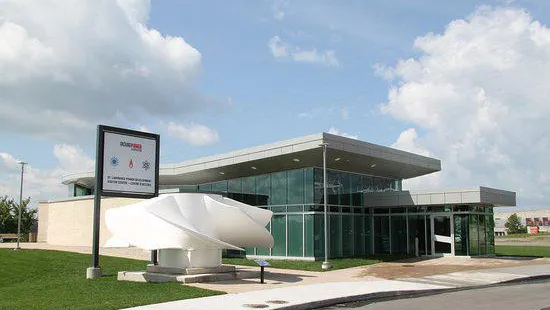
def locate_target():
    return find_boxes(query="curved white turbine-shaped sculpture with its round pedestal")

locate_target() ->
[105,193,273,268]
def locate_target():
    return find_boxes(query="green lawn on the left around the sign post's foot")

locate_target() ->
[0,249,223,309]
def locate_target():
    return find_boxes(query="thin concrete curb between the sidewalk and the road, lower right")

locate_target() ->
[277,274,550,310]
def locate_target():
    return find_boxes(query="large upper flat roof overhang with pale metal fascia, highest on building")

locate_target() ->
[62,133,441,187]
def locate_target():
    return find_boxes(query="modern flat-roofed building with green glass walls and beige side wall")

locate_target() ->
[39,133,516,260]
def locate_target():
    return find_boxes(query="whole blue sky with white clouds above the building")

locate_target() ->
[0,0,550,208]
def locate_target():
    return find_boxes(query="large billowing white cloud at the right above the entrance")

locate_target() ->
[377,6,550,204]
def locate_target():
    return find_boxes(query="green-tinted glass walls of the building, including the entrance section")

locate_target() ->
[86,167,500,259]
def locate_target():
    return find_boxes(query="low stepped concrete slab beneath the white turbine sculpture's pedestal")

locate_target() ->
[117,265,260,283]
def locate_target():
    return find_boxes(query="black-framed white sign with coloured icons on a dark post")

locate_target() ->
[86,125,160,279]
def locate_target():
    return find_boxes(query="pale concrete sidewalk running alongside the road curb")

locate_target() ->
[126,264,550,310]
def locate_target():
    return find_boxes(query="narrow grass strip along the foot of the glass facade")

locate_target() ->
[223,255,408,271]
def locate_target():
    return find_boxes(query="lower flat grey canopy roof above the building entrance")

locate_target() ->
[364,186,516,207]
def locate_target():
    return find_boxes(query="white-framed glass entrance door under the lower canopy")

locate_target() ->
[430,213,454,255]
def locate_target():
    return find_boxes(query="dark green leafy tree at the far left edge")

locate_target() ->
[0,196,37,239]
